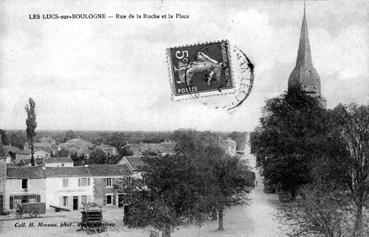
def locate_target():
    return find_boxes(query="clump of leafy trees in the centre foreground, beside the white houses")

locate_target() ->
[122,130,254,236]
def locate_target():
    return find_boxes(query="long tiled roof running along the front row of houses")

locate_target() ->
[6,165,131,179]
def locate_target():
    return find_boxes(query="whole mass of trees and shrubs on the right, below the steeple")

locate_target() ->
[251,91,369,236]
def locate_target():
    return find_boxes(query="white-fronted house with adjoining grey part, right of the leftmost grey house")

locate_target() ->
[46,165,131,210]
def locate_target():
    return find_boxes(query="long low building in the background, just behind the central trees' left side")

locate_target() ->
[127,142,176,156]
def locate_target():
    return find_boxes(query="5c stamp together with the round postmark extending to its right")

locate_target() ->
[167,40,254,111]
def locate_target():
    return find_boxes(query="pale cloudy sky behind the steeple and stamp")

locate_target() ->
[0,0,369,131]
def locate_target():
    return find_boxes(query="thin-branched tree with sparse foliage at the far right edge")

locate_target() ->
[333,104,369,236]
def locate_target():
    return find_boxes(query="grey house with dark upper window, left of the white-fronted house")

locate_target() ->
[5,166,46,211]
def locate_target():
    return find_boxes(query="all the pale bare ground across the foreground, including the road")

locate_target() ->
[0,143,284,237]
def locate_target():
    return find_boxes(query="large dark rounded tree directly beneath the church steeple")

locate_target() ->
[251,90,331,199]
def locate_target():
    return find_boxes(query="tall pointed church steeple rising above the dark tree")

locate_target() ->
[288,4,321,103]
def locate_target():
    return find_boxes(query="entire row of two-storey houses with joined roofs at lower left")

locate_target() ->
[0,156,132,213]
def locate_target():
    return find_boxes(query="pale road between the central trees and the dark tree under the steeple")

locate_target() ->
[173,143,284,237]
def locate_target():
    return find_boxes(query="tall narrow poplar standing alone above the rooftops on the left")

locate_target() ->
[25,98,37,166]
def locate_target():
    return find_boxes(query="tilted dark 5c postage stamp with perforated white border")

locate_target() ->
[167,40,235,101]
